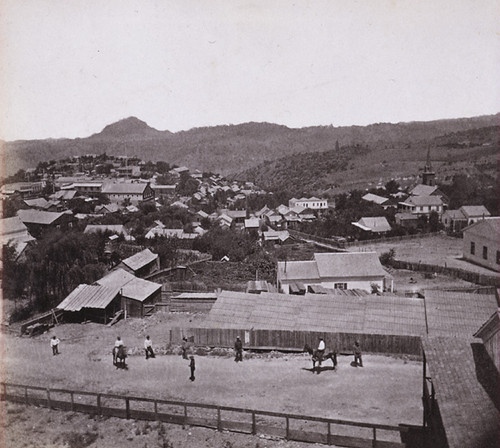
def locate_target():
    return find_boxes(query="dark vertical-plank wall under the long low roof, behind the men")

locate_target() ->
[169,328,422,356]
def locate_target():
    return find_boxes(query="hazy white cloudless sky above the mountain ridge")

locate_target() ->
[0,0,500,140]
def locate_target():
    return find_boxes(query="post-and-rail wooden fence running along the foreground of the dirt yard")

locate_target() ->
[1,383,412,448]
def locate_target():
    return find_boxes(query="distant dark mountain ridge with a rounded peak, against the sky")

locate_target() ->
[4,114,500,186]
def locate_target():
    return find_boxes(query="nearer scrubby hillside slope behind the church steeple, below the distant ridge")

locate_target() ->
[235,126,500,195]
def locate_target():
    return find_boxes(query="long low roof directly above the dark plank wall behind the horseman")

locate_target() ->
[205,290,425,335]
